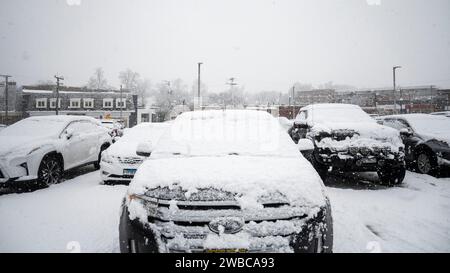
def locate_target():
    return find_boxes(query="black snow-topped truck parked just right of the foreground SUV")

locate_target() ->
[289,104,405,185]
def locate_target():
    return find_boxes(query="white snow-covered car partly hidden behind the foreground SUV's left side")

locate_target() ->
[100,123,169,185]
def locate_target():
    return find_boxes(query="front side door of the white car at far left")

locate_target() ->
[62,121,89,169]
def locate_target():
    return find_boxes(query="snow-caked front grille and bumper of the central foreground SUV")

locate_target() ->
[120,194,332,253]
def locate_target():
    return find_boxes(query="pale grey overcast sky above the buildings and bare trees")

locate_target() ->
[0,0,450,92]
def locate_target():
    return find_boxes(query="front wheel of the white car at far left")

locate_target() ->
[38,155,63,187]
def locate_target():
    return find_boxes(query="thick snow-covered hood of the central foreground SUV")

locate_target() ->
[129,154,325,208]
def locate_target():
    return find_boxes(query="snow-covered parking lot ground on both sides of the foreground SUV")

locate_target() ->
[0,165,450,252]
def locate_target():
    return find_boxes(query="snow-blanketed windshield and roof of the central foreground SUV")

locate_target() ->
[150,110,298,156]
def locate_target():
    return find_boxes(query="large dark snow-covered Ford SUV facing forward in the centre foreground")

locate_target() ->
[119,110,333,252]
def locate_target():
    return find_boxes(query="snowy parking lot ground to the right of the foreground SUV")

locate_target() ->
[326,172,450,252]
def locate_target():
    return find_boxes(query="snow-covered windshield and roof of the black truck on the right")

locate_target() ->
[307,104,376,123]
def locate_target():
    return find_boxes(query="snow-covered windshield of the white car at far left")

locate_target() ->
[0,119,67,137]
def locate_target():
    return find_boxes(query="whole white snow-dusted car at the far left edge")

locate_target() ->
[0,116,111,186]
